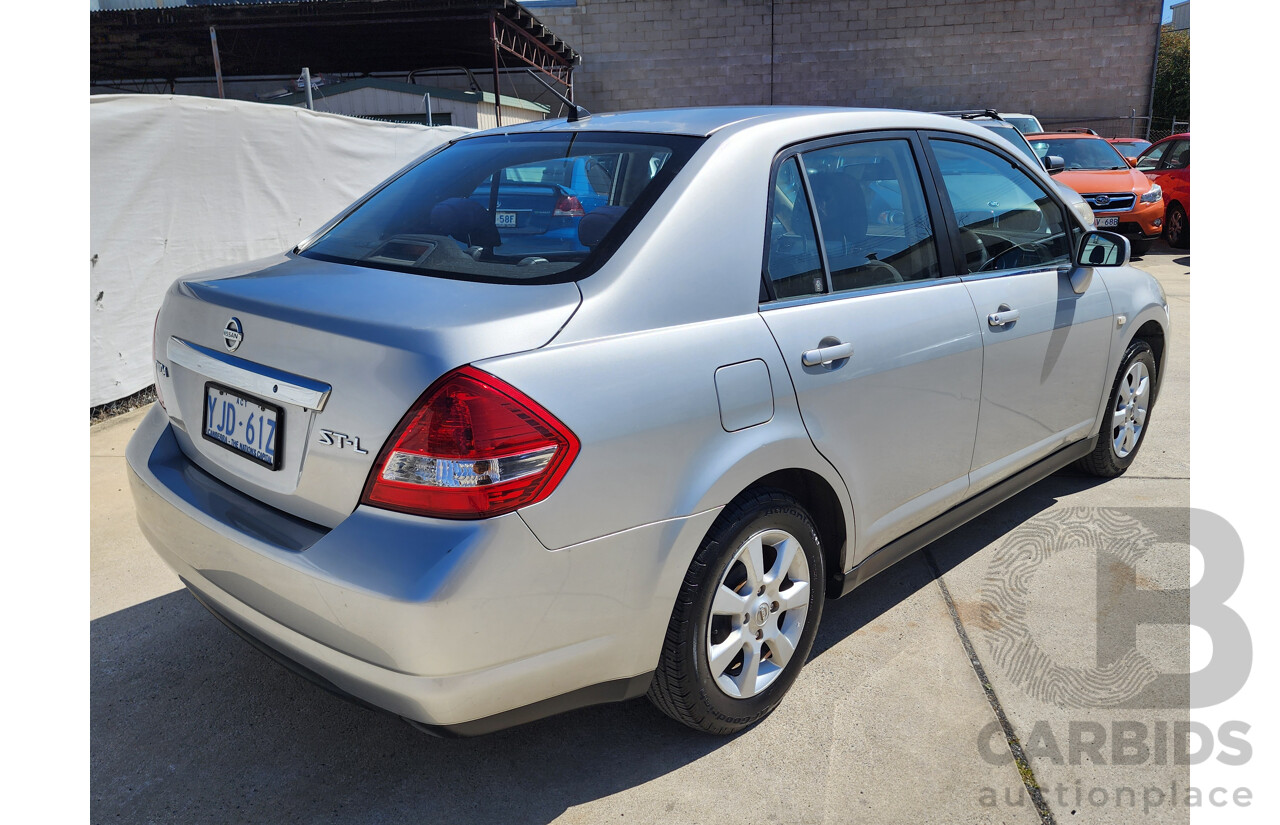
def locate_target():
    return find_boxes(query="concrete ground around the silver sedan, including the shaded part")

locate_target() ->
[90,246,1190,824]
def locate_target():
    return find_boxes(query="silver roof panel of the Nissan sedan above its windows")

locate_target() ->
[468,106,1008,137]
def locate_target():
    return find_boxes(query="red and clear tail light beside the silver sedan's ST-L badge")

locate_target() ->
[361,367,579,518]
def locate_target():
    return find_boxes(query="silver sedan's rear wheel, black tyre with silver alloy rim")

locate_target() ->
[649,489,826,734]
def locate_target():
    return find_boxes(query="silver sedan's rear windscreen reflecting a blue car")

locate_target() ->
[302,132,701,283]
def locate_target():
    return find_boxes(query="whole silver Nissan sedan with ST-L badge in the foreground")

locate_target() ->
[128,107,1169,734]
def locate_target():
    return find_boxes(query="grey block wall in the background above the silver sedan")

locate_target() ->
[534,0,1161,122]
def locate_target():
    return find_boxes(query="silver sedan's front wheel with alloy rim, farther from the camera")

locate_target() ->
[1075,340,1156,478]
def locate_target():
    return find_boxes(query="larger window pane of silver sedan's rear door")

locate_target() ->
[804,139,940,292]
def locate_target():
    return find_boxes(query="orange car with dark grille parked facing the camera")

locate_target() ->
[1027,132,1165,257]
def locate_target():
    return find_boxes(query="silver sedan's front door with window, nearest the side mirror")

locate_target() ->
[928,134,1114,492]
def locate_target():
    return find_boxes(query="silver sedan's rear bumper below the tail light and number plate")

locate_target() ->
[128,405,716,733]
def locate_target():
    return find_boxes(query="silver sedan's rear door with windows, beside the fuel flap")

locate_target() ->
[760,133,982,562]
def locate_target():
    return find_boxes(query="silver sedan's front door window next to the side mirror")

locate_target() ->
[931,139,1071,272]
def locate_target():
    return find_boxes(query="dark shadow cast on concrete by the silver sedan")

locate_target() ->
[90,465,1111,824]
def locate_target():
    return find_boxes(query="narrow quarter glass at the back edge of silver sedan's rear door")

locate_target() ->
[765,157,827,298]
